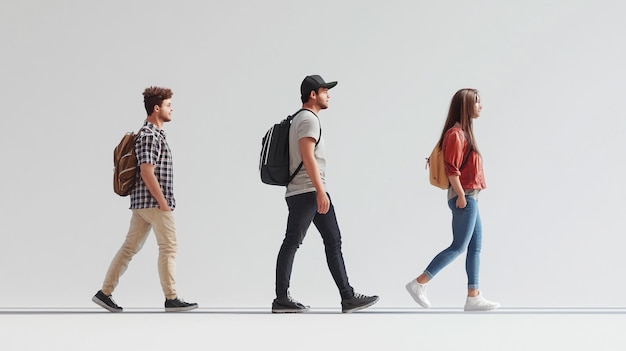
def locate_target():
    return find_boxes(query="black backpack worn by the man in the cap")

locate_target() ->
[259,109,322,186]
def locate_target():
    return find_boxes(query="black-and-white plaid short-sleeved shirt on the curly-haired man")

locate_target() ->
[130,121,176,210]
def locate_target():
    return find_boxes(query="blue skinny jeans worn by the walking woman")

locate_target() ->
[424,196,483,289]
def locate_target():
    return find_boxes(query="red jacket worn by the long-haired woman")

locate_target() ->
[442,127,487,190]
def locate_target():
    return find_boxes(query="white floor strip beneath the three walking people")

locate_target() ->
[0,308,626,351]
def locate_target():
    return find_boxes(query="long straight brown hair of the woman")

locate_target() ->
[439,89,480,152]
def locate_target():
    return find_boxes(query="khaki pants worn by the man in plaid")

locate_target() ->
[102,208,177,299]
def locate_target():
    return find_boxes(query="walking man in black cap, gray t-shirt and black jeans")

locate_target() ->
[272,75,378,313]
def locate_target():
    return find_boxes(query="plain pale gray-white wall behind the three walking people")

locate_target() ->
[0,0,626,307]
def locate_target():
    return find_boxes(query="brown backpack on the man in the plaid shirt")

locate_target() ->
[113,132,139,196]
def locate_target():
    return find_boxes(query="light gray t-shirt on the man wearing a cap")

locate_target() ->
[285,110,326,197]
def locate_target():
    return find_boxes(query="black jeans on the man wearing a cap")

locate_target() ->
[276,192,354,299]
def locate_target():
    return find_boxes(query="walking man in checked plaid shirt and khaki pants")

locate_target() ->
[92,87,198,312]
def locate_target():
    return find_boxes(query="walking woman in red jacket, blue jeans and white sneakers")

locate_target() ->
[406,89,500,311]
